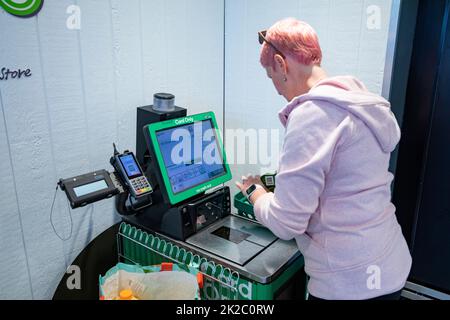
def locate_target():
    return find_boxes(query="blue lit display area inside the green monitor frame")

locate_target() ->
[156,120,226,194]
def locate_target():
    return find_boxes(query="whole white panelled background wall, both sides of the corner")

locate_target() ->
[0,0,391,299]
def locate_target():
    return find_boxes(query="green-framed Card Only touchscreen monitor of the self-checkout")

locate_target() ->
[148,112,231,204]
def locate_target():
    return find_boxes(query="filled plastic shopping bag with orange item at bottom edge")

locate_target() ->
[99,263,203,300]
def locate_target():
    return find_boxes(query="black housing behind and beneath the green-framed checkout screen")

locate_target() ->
[118,102,231,241]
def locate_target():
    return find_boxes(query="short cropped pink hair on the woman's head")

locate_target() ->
[260,18,322,68]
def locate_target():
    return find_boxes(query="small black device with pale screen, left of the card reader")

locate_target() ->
[58,170,120,209]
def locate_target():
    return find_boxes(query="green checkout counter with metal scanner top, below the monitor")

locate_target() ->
[118,194,306,300]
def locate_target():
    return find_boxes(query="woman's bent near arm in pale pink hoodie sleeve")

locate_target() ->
[252,102,351,240]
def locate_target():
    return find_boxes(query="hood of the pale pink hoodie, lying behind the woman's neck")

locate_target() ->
[279,76,401,153]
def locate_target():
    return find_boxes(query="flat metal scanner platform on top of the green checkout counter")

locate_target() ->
[123,215,303,284]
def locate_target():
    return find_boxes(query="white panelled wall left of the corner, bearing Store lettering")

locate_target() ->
[0,0,224,299]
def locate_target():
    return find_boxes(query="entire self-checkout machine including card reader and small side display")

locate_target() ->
[59,94,305,300]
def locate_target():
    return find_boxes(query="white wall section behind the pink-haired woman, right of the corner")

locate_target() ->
[225,0,392,192]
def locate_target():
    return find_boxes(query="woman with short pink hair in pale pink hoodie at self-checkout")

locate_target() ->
[236,18,411,300]
